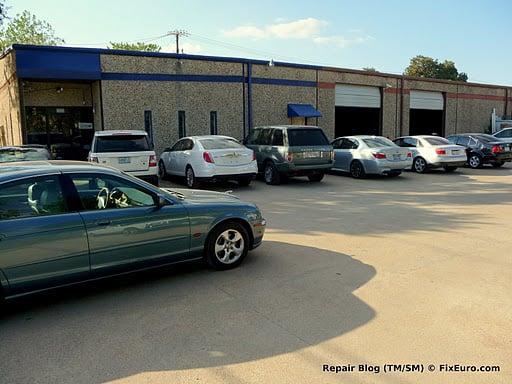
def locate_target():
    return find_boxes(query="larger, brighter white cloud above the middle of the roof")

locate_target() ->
[223,17,328,40]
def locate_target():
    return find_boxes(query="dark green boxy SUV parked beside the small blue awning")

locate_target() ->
[244,125,334,185]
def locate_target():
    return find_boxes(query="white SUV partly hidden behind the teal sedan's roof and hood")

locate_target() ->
[87,130,158,185]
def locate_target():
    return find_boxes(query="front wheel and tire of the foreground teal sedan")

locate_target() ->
[205,221,250,271]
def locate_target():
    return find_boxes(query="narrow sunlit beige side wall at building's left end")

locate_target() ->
[0,52,23,145]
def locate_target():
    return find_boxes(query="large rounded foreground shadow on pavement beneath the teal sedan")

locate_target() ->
[0,241,376,383]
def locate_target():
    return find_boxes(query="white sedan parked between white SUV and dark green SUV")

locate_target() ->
[158,135,258,188]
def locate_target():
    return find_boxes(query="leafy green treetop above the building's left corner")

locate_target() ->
[0,11,64,50]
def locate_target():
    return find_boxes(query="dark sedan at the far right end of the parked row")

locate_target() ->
[447,133,512,168]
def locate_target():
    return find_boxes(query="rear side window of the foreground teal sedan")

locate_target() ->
[0,176,68,220]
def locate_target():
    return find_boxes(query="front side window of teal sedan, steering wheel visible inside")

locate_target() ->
[70,174,156,211]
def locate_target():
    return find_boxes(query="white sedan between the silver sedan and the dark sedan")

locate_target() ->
[394,135,467,173]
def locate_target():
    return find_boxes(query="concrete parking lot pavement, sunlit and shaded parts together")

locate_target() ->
[0,165,512,384]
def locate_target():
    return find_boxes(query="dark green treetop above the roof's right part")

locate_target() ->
[404,55,468,81]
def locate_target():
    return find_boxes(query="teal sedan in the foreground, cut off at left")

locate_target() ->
[0,161,265,298]
